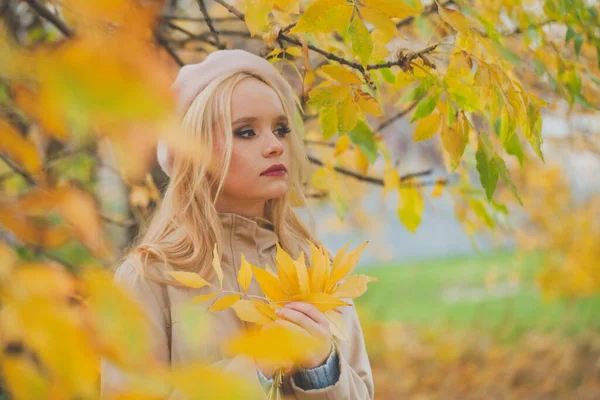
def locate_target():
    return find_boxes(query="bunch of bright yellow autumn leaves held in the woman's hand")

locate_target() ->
[168,242,378,399]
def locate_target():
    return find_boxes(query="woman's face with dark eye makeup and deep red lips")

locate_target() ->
[216,78,290,216]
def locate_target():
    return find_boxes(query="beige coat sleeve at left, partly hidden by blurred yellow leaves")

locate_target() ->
[100,262,266,400]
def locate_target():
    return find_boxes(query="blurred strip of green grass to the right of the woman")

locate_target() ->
[356,252,600,339]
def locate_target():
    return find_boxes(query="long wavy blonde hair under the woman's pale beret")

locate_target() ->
[124,71,320,287]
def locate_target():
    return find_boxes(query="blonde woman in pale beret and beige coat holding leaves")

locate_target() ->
[101,50,374,400]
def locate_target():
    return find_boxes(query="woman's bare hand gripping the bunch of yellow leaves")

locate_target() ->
[275,302,333,369]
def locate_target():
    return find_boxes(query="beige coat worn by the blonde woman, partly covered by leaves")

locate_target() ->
[101,213,374,400]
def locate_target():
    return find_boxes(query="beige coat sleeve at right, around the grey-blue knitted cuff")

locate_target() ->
[290,300,375,400]
